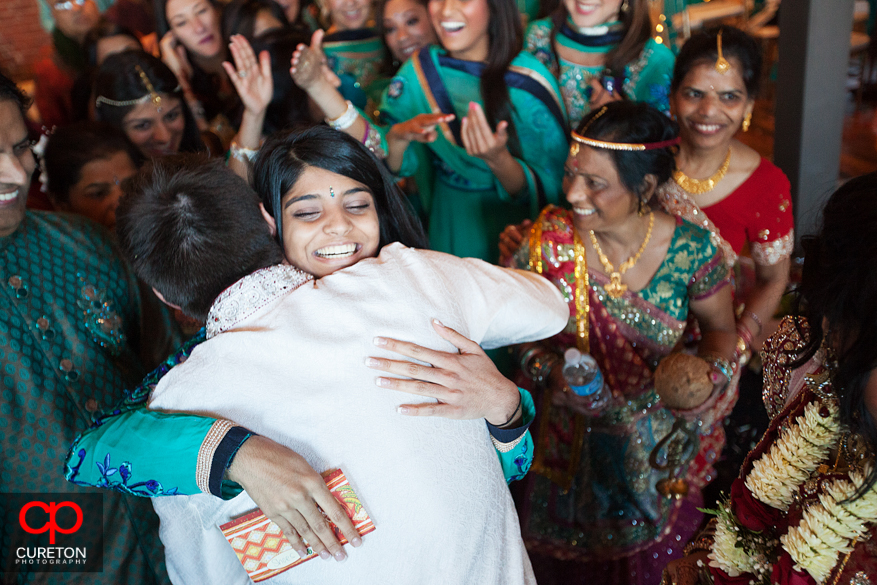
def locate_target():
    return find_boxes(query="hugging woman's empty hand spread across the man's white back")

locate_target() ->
[366,321,520,425]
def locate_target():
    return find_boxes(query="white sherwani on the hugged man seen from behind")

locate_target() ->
[120,157,568,585]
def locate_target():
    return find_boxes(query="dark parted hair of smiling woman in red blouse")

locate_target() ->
[670,26,761,99]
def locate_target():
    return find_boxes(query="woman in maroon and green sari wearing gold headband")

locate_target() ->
[506,102,735,584]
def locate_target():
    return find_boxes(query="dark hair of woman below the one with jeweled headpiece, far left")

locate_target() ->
[43,122,144,203]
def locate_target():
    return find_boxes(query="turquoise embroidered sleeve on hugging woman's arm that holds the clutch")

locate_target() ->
[64,329,250,497]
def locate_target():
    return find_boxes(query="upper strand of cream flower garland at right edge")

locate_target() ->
[746,400,841,512]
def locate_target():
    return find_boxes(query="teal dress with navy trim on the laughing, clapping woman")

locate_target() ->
[379,46,568,262]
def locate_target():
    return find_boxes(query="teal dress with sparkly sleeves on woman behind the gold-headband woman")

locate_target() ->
[524,18,676,129]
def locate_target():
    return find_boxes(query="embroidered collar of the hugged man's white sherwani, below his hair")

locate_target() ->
[207,264,314,339]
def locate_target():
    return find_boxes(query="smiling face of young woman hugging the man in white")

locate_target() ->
[281,167,381,278]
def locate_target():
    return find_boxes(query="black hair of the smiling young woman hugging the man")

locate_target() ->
[253,126,429,248]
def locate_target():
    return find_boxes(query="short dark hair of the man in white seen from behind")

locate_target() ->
[116,155,283,320]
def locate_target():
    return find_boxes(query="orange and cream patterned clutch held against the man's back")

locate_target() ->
[220,469,375,583]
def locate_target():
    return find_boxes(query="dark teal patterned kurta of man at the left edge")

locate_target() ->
[0,212,169,584]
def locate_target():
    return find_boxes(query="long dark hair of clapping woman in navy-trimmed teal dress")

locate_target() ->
[481,0,524,156]
